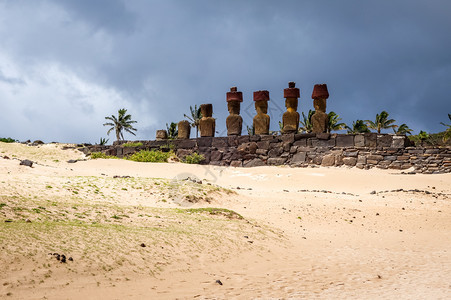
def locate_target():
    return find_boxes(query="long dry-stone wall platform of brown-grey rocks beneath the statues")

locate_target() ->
[80,133,451,174]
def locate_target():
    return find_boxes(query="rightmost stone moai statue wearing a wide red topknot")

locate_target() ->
[312,84,329,133]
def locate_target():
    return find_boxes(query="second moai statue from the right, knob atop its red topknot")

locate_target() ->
[282,82,300,133]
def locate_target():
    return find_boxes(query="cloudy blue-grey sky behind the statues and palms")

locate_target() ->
[0,0,451,143]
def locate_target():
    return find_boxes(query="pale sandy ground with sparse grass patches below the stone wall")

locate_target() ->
[0,143,451,299]
